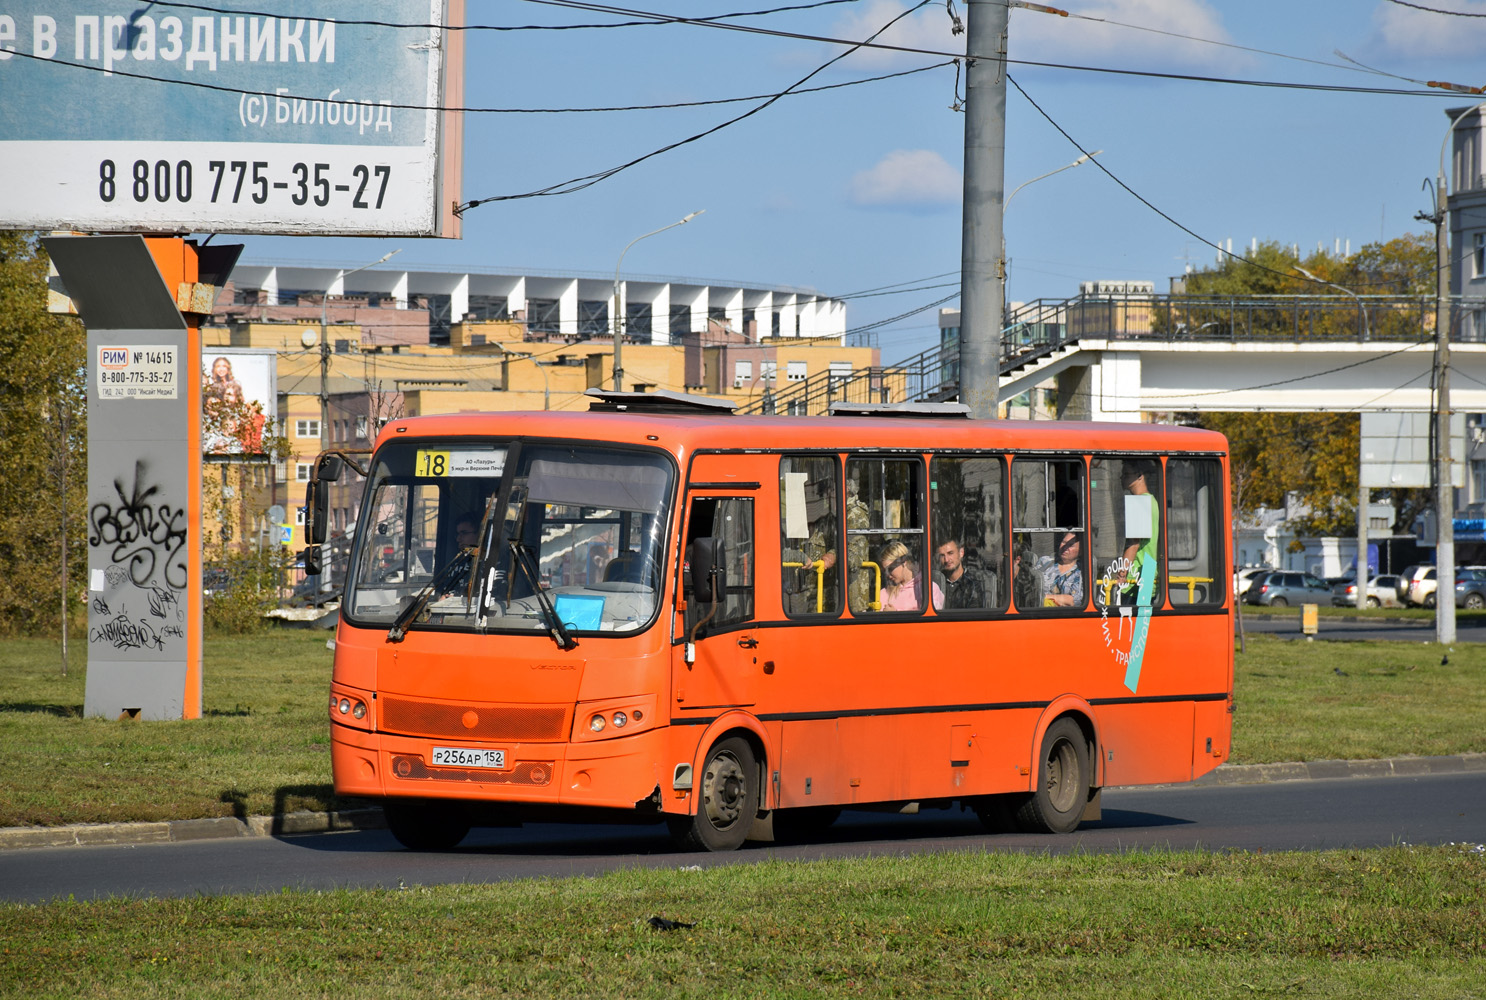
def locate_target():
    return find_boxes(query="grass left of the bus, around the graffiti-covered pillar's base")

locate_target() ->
[0,630,333,826]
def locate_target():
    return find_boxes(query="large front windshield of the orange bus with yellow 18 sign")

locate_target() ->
[345,440,675,634]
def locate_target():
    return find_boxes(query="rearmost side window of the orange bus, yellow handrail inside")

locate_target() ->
[1167,458,1227,606]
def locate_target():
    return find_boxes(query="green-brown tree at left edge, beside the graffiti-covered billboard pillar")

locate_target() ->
[0,230,88,650]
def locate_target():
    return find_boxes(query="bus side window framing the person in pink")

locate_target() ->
[846,458,942,615]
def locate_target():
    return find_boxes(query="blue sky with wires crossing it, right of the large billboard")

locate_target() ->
[234,0,1486,360]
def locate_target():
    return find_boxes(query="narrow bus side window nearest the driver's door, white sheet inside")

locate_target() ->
[779,455,841,617]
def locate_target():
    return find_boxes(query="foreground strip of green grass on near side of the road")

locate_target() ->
[0,847,1486,1000]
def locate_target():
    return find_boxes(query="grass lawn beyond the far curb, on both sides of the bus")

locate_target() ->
[0,630,1486,826]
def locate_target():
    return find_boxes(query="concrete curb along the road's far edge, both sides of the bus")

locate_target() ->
[0,753,1486,850]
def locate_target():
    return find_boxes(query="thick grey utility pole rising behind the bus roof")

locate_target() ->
[960,0,1009,419]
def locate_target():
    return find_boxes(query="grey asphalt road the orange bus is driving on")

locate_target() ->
[0,773,1486,902]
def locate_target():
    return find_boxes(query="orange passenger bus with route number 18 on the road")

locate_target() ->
[306,389,1233,850]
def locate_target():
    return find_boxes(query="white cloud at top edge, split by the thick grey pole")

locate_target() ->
[832,0,1236,71]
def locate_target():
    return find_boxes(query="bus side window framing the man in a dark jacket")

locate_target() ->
[929,456,1010,614]
